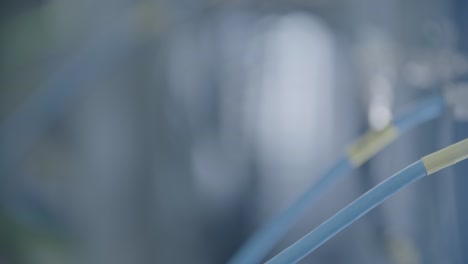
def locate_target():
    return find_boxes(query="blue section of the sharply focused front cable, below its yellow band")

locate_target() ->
[267,160,427,264]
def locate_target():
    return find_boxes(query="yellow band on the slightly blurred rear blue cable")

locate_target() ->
[348,125,398,167]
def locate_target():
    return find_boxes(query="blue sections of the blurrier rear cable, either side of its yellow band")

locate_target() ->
[228,93,445,264]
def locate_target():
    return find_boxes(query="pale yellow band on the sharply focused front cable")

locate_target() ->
[421,139,468,175]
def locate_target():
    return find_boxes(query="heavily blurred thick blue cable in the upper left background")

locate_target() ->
[0,15,133,170]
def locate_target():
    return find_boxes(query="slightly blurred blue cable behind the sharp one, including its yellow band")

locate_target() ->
[229,94,445,264]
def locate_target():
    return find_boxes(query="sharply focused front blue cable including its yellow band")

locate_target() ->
[267,139,468,264]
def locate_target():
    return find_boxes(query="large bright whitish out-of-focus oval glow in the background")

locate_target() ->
[259,14,333,171]
